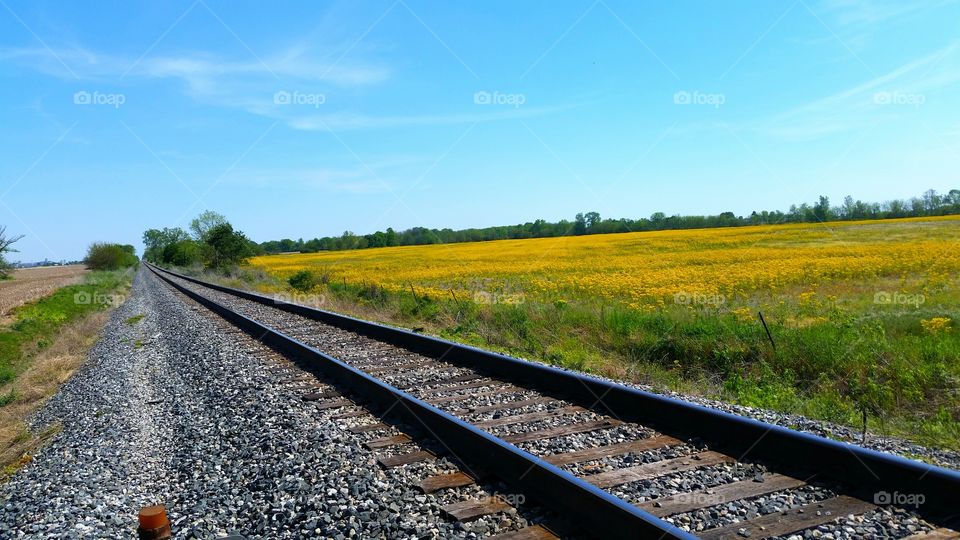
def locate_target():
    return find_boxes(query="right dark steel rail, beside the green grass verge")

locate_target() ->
[151,265,960,527]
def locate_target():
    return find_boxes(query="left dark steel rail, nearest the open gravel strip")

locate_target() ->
[147,264,696,540]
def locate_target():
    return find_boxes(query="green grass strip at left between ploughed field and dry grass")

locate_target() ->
[0,271,130,384]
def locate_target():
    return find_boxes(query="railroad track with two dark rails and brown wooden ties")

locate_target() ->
[147,265,960,540]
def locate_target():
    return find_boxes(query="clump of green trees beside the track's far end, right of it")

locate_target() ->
[143,210,263,270]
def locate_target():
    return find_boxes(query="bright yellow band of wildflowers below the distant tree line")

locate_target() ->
[251,216,960,309]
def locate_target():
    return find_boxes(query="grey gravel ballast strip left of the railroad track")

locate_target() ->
[0,269,526,538]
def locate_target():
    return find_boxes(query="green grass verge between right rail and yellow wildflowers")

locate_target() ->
[195,270,960,450]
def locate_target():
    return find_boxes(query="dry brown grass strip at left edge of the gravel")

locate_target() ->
[0,311,109,482]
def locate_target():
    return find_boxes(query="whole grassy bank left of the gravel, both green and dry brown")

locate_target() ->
[0,270,132,481]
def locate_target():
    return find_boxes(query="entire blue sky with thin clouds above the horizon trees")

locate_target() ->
[0,0,960,261]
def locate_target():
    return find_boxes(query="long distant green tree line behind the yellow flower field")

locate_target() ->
[259,189,960,253]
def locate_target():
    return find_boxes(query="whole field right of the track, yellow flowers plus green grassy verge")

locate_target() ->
[250,217,960,447]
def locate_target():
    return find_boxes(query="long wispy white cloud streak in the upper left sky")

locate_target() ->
[0,45,569,131]
